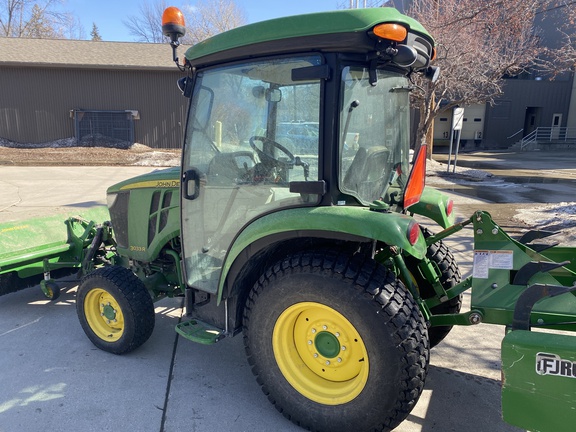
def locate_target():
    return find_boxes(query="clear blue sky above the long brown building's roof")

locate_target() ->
[62,0,349,41]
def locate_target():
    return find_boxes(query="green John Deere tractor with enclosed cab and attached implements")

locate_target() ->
[0,8,576,432]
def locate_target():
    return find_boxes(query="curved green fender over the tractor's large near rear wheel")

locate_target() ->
[218,206,426,302]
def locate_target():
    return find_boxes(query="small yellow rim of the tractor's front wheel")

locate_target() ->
[84,288,124,342]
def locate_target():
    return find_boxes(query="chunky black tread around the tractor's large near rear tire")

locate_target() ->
[243,250,430,431]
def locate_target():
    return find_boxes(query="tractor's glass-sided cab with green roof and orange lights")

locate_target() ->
[164,8,435,293]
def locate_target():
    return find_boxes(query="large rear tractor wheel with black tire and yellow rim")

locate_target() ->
[244,251,429,432]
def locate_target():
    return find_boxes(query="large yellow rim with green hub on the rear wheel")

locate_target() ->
[272,302,369,405]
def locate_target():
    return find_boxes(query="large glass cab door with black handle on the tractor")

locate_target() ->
[181,56,320,293]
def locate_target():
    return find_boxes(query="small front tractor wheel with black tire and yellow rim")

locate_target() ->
[76,266,155,354]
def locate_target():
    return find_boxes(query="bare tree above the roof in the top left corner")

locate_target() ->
[0,0,70,38]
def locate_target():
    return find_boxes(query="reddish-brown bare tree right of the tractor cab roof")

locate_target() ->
[406,0,576,152]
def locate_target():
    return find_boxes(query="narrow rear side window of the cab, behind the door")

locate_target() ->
[339,67,410,205]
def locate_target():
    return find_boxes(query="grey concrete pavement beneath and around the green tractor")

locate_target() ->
[0,167,518,432]
